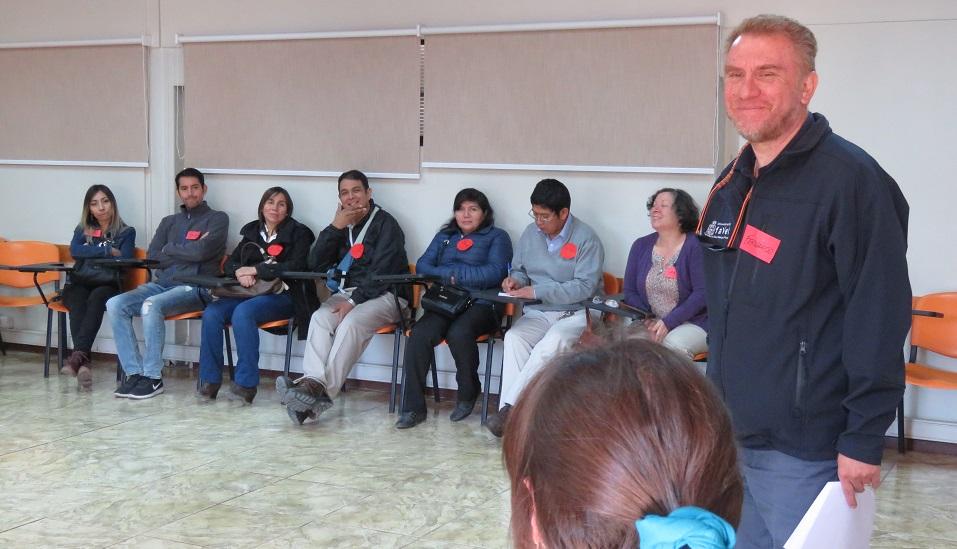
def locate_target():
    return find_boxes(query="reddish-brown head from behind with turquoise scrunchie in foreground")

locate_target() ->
[502,338,743,549]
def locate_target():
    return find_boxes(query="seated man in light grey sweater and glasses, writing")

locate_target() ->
[487,179,605,437]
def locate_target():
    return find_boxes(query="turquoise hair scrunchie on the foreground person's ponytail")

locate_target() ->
[635,506,735,549]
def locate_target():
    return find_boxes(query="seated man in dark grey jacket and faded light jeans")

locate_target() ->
[106,168,229,400]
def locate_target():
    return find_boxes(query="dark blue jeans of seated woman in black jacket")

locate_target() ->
[199,292,292,388]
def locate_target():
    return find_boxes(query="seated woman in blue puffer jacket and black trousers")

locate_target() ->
[395,188,512,429]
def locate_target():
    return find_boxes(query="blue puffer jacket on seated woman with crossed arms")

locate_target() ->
[415,225,512,290]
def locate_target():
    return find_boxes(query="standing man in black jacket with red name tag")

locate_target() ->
[698,16,911,548]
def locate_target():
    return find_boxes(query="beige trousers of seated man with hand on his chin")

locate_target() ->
[302,292,406,398]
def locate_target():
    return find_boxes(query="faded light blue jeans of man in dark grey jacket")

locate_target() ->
[106,282,208,379]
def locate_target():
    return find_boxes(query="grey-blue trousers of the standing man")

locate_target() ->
[735,448,837,549]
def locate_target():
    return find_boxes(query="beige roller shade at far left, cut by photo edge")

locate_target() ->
[0,45,149,164]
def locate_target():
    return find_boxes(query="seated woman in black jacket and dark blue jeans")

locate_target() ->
[199,187,318,404]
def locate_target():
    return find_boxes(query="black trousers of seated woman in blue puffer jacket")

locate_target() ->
[401,303,501,412]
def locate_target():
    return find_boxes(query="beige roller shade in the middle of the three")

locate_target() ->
[184,36,420,174]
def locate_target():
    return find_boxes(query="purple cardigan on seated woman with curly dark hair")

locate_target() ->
[625,233,708,331]
